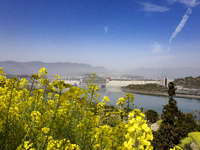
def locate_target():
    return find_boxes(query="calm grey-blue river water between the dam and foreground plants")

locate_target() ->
[98,87,200,114]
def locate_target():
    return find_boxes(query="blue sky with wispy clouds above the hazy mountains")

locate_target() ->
[0,0,200,70]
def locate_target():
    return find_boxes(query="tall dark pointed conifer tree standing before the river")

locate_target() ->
[152,83,181,150]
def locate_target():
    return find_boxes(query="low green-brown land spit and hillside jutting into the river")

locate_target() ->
[121,76,200,99]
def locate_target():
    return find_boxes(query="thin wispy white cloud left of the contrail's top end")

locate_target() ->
[140,3,169,12]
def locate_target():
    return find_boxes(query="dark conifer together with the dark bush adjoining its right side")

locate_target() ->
[152,82,199,150]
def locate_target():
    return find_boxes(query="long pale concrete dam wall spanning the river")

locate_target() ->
[63,77,173,88]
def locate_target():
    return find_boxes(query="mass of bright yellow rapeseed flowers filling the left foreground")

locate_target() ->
[0,68,153,150]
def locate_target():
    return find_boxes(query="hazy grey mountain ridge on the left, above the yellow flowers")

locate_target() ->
[0,61,108,76]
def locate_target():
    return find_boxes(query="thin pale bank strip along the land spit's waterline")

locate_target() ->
[120,88,200,99]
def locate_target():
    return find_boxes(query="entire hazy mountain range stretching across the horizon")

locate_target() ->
[0,61,200,79]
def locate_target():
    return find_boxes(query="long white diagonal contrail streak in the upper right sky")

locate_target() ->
[169,8,192,43]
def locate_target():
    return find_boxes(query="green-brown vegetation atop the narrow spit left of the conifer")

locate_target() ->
[122,84,167,93]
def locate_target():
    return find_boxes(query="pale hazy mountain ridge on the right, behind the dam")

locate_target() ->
[126,67,200,79]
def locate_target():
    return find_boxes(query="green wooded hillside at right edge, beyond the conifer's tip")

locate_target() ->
[174,76,200,89]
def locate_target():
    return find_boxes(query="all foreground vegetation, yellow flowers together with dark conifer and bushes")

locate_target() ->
[0,68,199,150]
